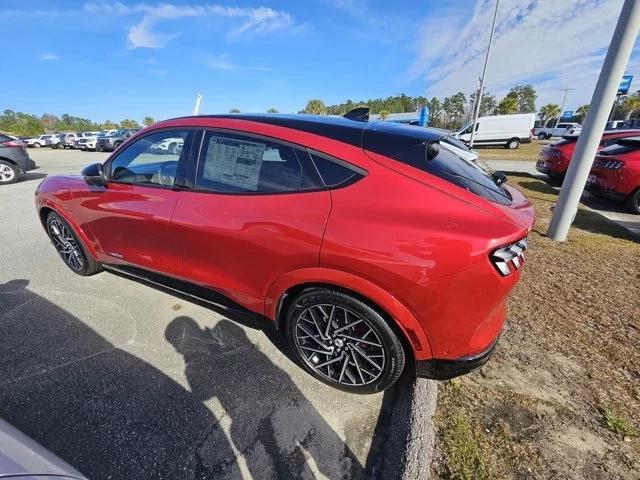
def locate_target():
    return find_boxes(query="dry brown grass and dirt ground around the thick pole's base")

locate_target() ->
[433,177,640,479]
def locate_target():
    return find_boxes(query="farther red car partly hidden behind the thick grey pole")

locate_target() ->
[536,130,640,181]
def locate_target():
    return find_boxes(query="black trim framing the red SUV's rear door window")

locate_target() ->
[192,127,327,196]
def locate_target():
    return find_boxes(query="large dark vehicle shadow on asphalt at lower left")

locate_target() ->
[0,280,242,480]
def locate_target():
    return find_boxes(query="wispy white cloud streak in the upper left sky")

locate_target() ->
[84,2,294,49]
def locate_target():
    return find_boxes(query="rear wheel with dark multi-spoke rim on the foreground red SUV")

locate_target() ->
[285,288,405,394]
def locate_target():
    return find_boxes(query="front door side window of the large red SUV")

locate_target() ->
[109,130,189,187]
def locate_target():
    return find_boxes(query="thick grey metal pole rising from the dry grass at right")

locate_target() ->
[547,0,640,241]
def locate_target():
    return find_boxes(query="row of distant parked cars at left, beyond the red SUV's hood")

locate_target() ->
[20,128,140,152]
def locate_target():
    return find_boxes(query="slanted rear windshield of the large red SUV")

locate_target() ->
[391,142,511,205]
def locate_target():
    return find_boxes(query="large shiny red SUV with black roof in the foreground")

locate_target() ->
[36,115,534,393]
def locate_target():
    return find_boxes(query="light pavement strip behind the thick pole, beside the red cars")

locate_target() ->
[485,160,640,237]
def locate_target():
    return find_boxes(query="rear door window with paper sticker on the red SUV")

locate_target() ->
[196,132,324,193]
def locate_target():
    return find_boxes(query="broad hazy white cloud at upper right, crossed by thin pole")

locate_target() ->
[410,0,636,106]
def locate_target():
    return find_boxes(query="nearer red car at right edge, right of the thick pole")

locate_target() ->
[586,136,640,214]
